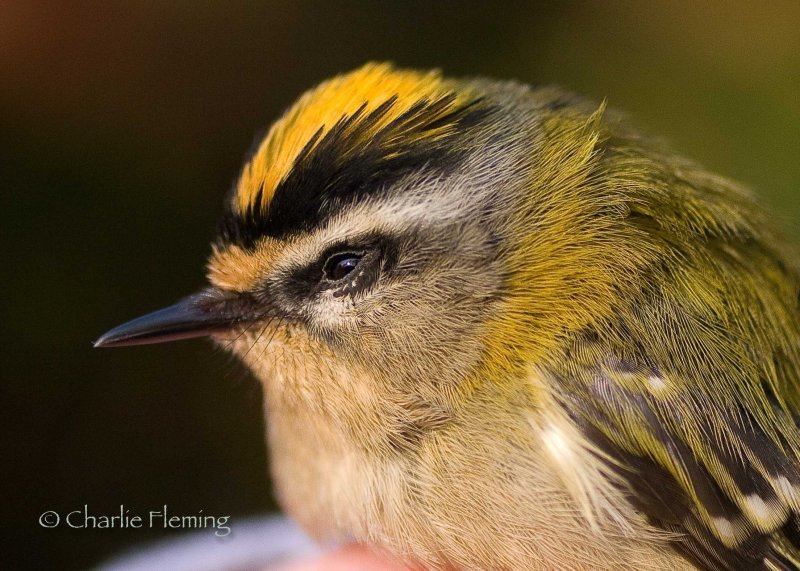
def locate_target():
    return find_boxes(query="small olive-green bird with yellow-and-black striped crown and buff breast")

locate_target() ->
[96,62,800,571]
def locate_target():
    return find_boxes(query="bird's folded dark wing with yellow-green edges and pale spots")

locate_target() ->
[555,328,800,571]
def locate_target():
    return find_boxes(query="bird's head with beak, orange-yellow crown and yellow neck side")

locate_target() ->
[97,64,642,434]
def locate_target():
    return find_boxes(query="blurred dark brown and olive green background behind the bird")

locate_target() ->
[0,0,800,569]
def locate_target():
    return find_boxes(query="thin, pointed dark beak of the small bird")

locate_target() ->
[94,288,249,347]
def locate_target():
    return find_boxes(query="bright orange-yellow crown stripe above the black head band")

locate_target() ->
[234,63,467,213]
